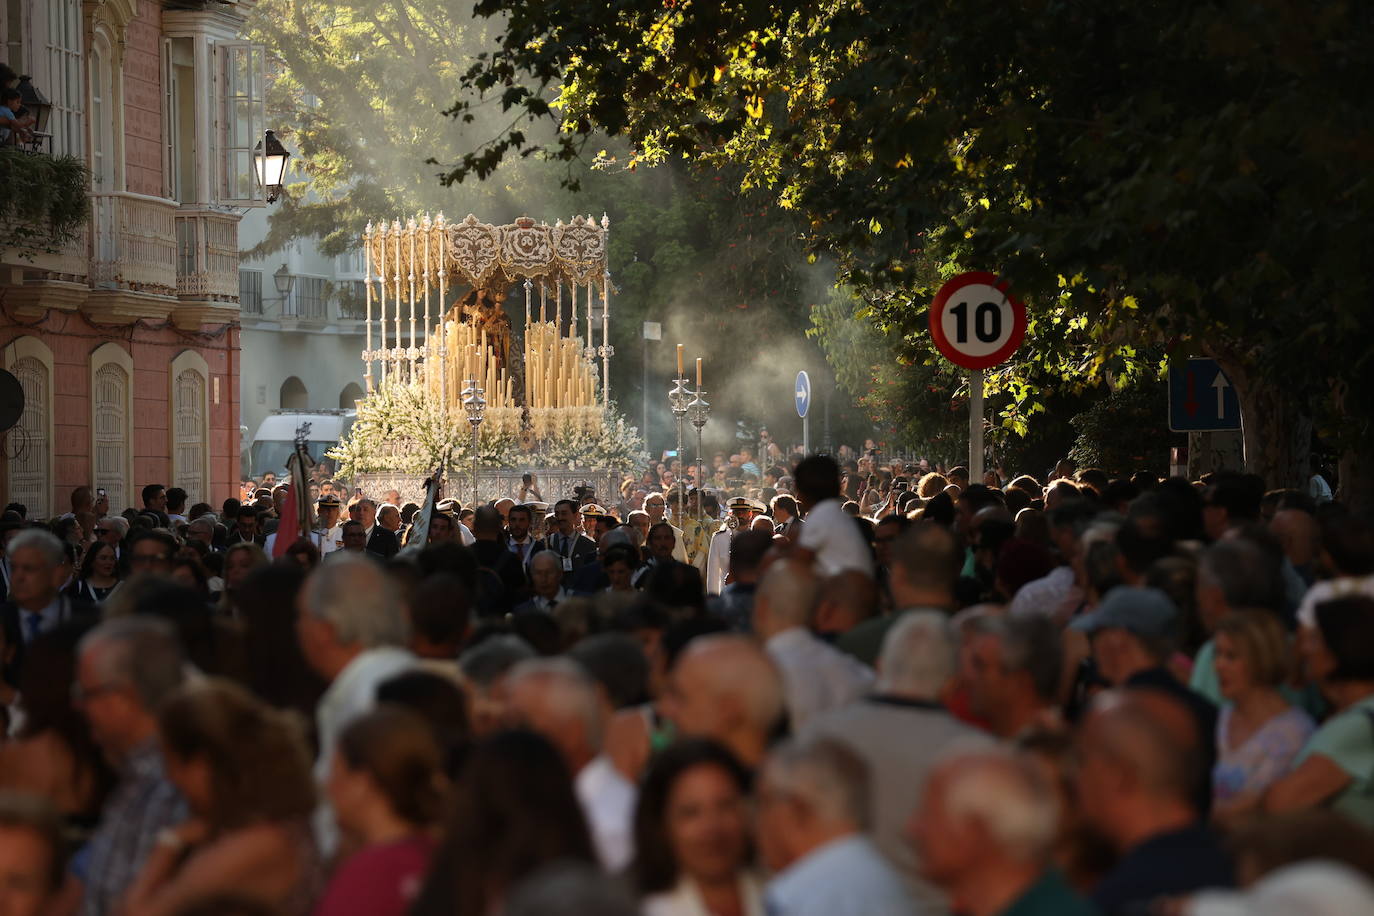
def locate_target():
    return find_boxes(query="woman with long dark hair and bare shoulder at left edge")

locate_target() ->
[0,625,113,829]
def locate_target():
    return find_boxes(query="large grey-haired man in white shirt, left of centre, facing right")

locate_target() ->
[295,554,415,856]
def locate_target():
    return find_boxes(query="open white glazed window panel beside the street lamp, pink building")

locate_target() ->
[216,41,267,203]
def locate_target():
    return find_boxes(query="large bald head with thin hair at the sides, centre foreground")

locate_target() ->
[660,636,786,770]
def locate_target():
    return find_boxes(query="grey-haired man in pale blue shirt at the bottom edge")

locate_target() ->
[757,739,918,916]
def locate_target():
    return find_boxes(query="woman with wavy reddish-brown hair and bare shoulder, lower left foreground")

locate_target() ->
[124,678,322,916]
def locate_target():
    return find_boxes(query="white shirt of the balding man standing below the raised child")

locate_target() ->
[764,626,874,731]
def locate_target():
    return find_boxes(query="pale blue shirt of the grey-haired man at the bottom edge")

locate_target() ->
[764,834,915,916]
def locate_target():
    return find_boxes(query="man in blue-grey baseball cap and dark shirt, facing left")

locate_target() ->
[1069,585,1216,814]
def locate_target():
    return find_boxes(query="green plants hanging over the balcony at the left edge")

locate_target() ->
[0,147,91,251]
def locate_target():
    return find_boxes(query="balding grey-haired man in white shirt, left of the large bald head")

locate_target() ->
[506,659,639,873]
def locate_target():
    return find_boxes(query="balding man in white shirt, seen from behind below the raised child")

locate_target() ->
[753,560,872,731]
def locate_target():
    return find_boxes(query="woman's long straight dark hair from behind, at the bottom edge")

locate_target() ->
[411,732,596,916]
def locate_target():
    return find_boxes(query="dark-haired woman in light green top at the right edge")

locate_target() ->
[1264,596,1374,827]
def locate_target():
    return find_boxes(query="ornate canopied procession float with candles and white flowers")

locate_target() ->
[328,214,647,503]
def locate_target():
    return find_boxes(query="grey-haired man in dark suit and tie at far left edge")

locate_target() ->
[0,529,100,684]
